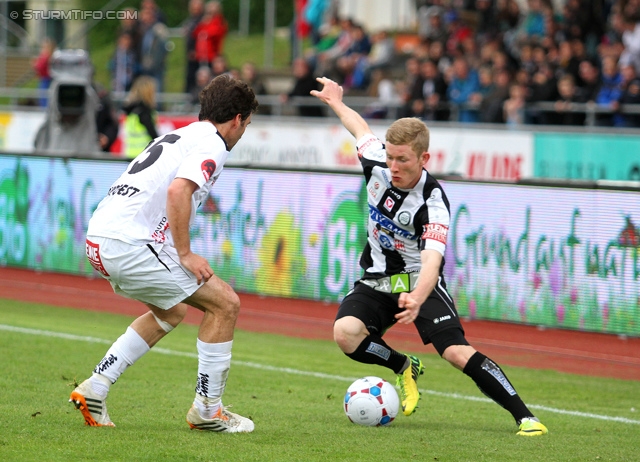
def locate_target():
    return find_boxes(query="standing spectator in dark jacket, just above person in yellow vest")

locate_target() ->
[140,8,168,93]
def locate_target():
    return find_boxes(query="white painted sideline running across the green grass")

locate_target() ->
[0,324,640,425]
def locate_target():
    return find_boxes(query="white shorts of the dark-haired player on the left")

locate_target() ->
[86,236,200,310]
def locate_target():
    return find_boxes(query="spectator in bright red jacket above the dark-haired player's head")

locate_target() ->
[192,1,228,71]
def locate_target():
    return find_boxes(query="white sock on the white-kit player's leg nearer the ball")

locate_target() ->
[193,339,233,419]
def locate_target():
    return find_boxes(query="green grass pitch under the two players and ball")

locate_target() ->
[0,300,640,462]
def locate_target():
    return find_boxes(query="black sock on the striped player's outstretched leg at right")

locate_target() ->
[463,352,533,423]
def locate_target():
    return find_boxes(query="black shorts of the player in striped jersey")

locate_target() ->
[336,282,469,355]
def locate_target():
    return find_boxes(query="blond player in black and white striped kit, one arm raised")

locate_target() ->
[311,77,547,436]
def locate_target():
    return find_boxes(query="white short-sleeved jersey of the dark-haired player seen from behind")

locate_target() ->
[87,122,229,245]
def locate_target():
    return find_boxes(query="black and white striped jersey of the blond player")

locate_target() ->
[356,134,450,278]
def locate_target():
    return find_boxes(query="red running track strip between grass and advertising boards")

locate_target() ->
[0,268,640,380]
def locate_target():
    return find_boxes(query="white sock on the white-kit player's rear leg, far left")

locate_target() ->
[92,327,149,384]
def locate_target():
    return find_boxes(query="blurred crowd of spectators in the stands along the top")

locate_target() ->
[99,0,640,127]
